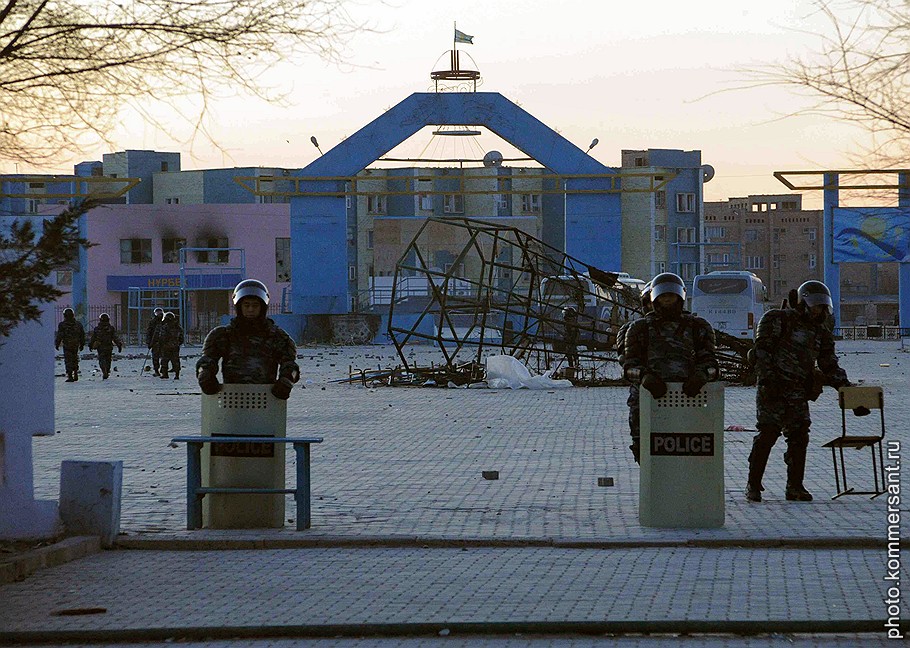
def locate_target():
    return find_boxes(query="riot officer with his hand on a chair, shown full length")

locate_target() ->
[746,281,850,502]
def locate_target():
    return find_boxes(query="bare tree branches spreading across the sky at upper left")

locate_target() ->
[0,0,365,164]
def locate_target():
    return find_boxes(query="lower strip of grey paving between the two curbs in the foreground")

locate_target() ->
[0,547,907,639]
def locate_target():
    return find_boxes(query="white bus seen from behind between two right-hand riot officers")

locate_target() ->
[692,270,767,338]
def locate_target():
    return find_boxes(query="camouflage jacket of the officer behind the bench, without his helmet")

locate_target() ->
[196,316,300,385]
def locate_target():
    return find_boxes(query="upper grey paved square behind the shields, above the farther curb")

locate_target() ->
[34,342,910,542]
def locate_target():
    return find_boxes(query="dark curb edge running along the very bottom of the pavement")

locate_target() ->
[0,619,896,645]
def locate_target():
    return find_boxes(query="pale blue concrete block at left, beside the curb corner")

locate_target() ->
[60,460,123,547]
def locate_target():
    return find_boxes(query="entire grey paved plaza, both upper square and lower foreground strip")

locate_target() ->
[0,342,910,646]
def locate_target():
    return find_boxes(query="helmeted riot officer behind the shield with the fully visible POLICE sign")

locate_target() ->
[623,272,718,463]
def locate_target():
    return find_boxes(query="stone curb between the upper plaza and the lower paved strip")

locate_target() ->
[116,536,896,551]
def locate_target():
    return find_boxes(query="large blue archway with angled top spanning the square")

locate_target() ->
[290,92,621,315]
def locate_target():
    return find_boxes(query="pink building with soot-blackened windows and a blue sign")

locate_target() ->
[57,204,291,343]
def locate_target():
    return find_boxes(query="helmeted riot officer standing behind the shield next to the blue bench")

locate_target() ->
[196,279,300,399]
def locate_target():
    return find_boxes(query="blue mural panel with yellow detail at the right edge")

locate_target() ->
[834,207,910,263]
